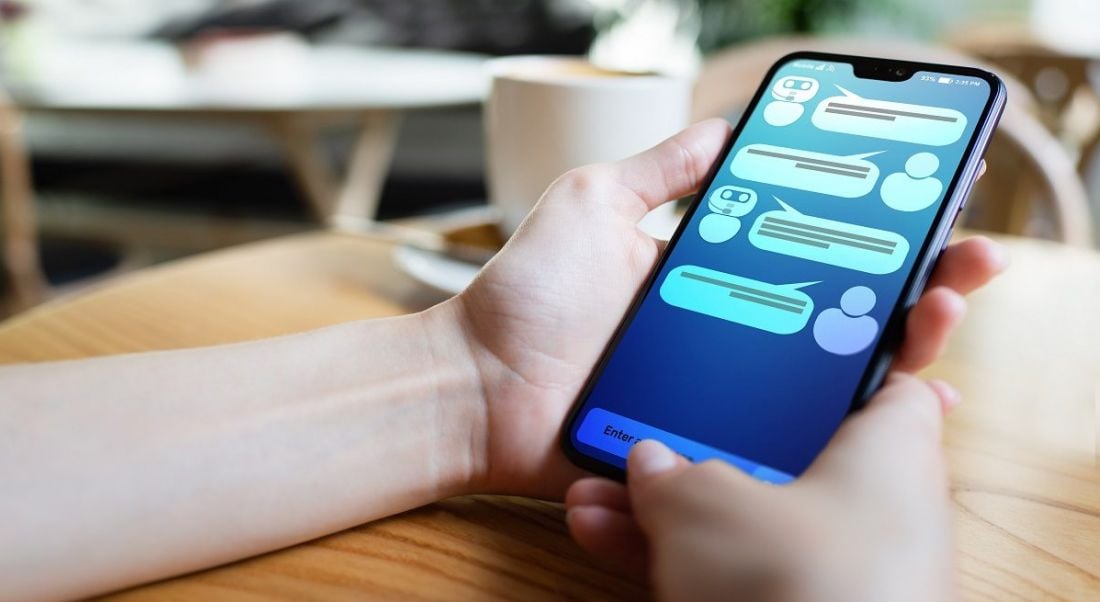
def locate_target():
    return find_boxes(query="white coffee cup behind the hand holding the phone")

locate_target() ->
[485,56,692,237]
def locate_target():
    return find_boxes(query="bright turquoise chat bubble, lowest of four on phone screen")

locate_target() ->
[661,265,817,335]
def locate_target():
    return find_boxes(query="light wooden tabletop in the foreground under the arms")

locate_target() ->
[0,233,1100,600]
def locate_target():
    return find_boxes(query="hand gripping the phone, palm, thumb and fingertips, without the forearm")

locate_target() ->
[439,120,1004,499]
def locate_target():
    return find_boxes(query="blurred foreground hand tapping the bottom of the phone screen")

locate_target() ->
[565,374,958,602]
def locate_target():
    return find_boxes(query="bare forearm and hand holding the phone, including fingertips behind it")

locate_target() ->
[0,121,1004,599]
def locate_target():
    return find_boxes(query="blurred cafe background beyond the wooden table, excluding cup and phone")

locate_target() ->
[0,0,1100,313]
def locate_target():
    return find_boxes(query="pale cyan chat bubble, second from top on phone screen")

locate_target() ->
[729,144,882,198]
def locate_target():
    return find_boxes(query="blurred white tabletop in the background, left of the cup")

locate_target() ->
[4,41,488,113]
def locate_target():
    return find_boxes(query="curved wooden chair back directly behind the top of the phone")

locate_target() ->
[693,36,1092,247]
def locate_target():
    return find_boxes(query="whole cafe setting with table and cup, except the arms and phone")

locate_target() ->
[0,0,1100,600]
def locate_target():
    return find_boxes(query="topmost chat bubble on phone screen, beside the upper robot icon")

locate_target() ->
[811,86,967,146]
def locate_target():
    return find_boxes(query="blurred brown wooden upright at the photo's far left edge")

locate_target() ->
[0,89,46,310]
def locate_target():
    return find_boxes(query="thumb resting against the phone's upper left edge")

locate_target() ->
[612,119,730,219]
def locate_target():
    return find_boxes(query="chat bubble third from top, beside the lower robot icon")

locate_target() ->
[749,197,909,274]
